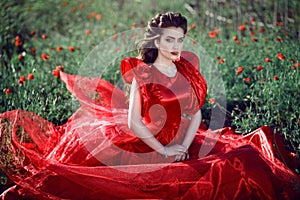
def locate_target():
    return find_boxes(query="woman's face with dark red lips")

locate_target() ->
[157,27,184,60]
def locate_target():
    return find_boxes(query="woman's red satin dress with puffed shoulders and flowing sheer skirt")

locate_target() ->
[0,52,300,199]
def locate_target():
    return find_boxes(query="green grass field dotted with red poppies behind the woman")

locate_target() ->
[0,0,300,189]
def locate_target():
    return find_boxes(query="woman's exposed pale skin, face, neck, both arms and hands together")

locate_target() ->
[128,27,202,161]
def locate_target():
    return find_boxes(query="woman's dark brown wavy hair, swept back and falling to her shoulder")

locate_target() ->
[137,12,187,63]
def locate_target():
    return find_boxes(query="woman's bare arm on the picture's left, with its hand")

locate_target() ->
[128,79,184,156]
